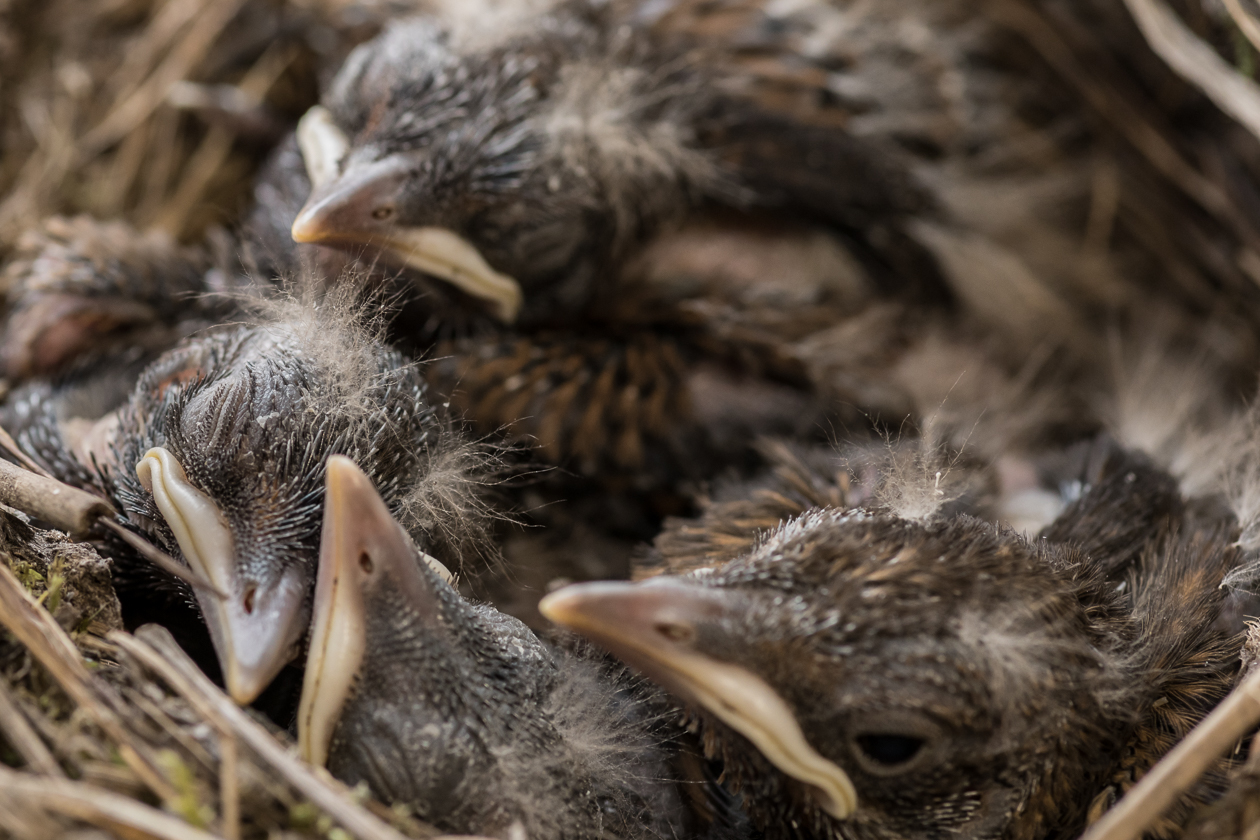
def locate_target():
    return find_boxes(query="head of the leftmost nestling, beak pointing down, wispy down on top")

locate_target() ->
[98,322,440,703]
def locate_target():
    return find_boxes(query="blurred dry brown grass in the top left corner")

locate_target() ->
[0,0,408,256]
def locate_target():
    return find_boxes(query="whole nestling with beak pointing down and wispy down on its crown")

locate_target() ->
[5,292,488,703]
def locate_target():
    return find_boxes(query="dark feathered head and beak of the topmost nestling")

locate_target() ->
[292,13,709,322]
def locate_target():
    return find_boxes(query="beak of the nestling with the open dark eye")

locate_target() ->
[538,578,858,820]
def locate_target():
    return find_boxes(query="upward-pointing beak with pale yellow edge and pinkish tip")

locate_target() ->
[297,455,451,766]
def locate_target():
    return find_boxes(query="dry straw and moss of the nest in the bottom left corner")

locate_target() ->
[0,443,448,840]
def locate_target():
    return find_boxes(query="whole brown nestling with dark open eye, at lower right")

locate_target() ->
[541,450,1239,840]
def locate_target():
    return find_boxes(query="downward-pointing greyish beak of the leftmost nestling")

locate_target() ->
[136,446,306,705]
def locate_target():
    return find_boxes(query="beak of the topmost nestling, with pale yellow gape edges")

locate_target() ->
[291,106,522,324]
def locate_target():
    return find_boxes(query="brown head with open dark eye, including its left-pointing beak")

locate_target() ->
[541,509,1124,837]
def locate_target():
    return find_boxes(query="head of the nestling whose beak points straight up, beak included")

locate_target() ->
[297,456,599,832]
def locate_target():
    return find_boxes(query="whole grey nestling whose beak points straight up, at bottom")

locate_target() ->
[297,455,710,840]
